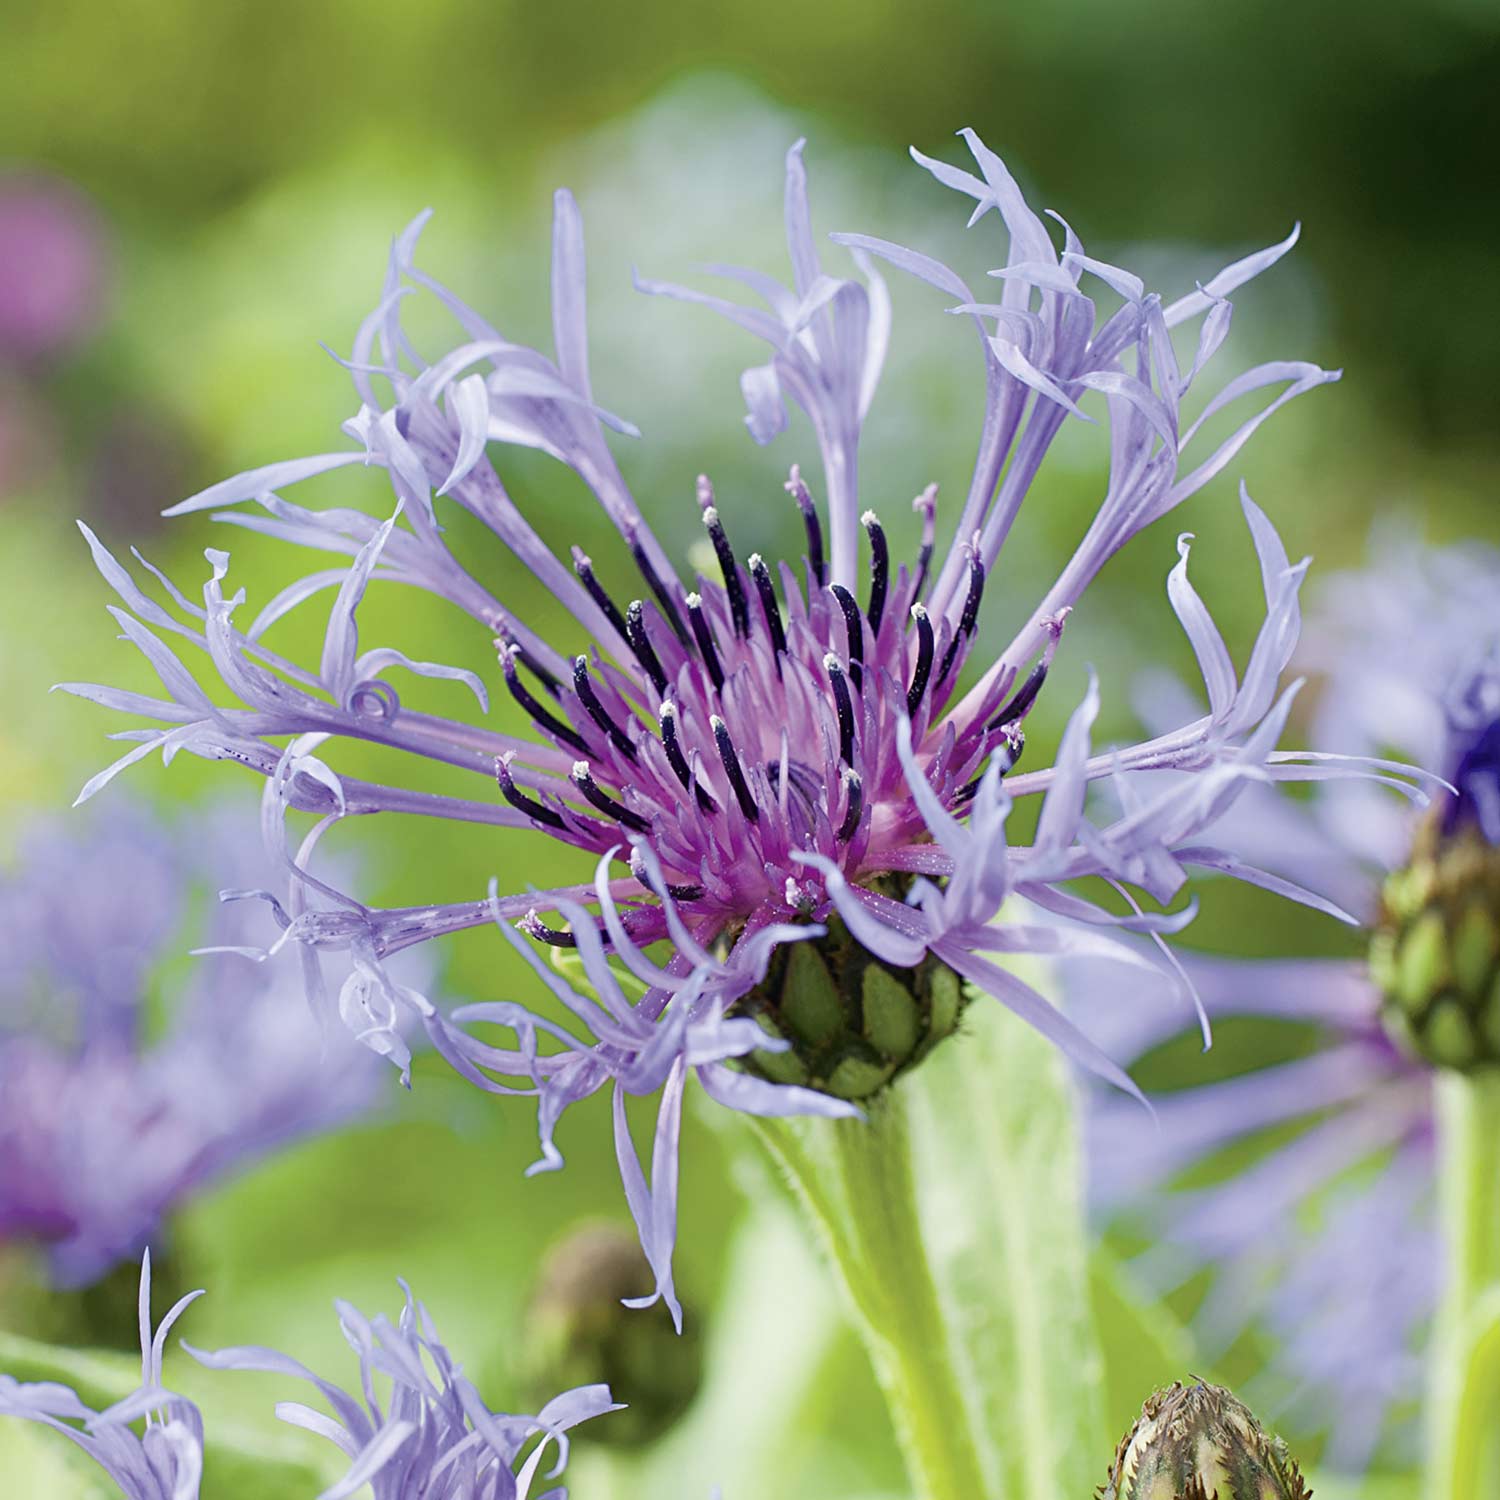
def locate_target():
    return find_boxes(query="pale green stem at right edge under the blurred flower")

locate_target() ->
[1428,1070,1500,1500]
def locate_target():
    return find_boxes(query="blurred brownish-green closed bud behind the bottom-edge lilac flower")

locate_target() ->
[525,1224,704,1448]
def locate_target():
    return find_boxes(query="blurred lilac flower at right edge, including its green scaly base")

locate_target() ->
[1074,527,1500,1472]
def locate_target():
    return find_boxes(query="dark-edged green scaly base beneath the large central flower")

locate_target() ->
[740,891,965,1100]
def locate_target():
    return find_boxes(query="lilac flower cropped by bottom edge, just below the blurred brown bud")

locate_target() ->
[183,1281,621,1500]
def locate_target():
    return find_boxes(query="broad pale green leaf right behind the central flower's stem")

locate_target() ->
[906,993,1116,1500]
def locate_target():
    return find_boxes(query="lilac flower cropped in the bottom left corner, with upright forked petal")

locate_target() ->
[0,1251,203,1500]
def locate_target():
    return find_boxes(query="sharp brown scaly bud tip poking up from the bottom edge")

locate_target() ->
[1098,1380,1313,1500]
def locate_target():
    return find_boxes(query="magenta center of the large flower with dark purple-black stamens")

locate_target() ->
[497,470,1050,941]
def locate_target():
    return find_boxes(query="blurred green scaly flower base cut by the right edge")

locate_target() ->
[1370,816,1500,1071]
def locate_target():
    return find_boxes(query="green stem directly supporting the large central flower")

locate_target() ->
[756,1092,996,1500]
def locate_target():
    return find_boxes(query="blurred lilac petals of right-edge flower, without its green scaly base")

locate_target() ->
[1076,536,1500,1469]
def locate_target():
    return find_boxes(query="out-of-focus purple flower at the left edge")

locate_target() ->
[0,806,381,1286]
